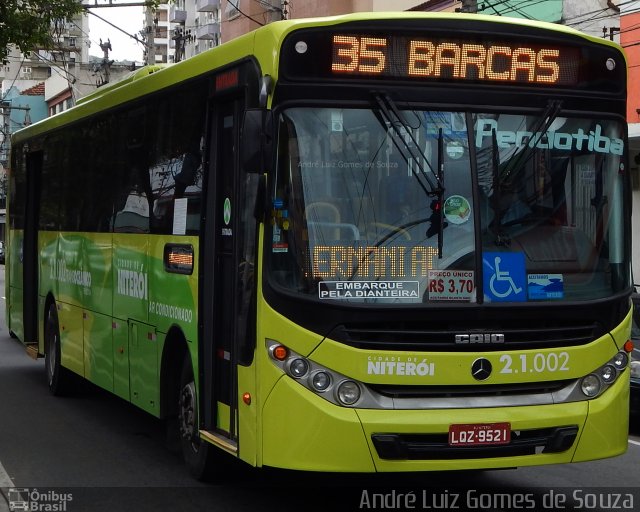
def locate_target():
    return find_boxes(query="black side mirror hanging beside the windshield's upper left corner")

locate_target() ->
[240,108,273,174]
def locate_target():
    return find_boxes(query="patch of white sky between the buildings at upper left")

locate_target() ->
[89,7,144,62]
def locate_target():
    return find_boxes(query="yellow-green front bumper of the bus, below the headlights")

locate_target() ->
[261,372,629,472]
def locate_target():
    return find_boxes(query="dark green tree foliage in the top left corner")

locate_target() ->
[0,0,83,59]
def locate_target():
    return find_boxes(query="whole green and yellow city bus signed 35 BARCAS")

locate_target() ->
[6,12,632,477]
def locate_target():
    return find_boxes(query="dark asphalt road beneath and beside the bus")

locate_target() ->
[0,267,640,512]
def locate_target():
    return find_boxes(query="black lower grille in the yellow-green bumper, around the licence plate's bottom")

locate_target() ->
[371,425,578,460]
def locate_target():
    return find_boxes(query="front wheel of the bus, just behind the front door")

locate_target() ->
[178,352,215,481]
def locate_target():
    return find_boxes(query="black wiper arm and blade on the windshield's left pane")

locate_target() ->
[374,93,445,258]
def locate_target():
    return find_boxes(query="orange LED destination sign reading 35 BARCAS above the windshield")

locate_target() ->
[331,35,577,85]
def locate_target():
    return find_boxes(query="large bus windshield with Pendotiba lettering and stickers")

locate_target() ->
[268,105,629,304]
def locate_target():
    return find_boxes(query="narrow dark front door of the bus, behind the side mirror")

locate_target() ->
[200,95,242,451]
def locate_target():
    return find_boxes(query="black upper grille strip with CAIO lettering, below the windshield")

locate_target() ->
[329,318,605,352]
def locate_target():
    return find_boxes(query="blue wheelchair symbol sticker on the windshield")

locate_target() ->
[482,252,527,302]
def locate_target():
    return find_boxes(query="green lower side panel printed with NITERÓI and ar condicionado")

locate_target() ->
[34,231,198,415]
